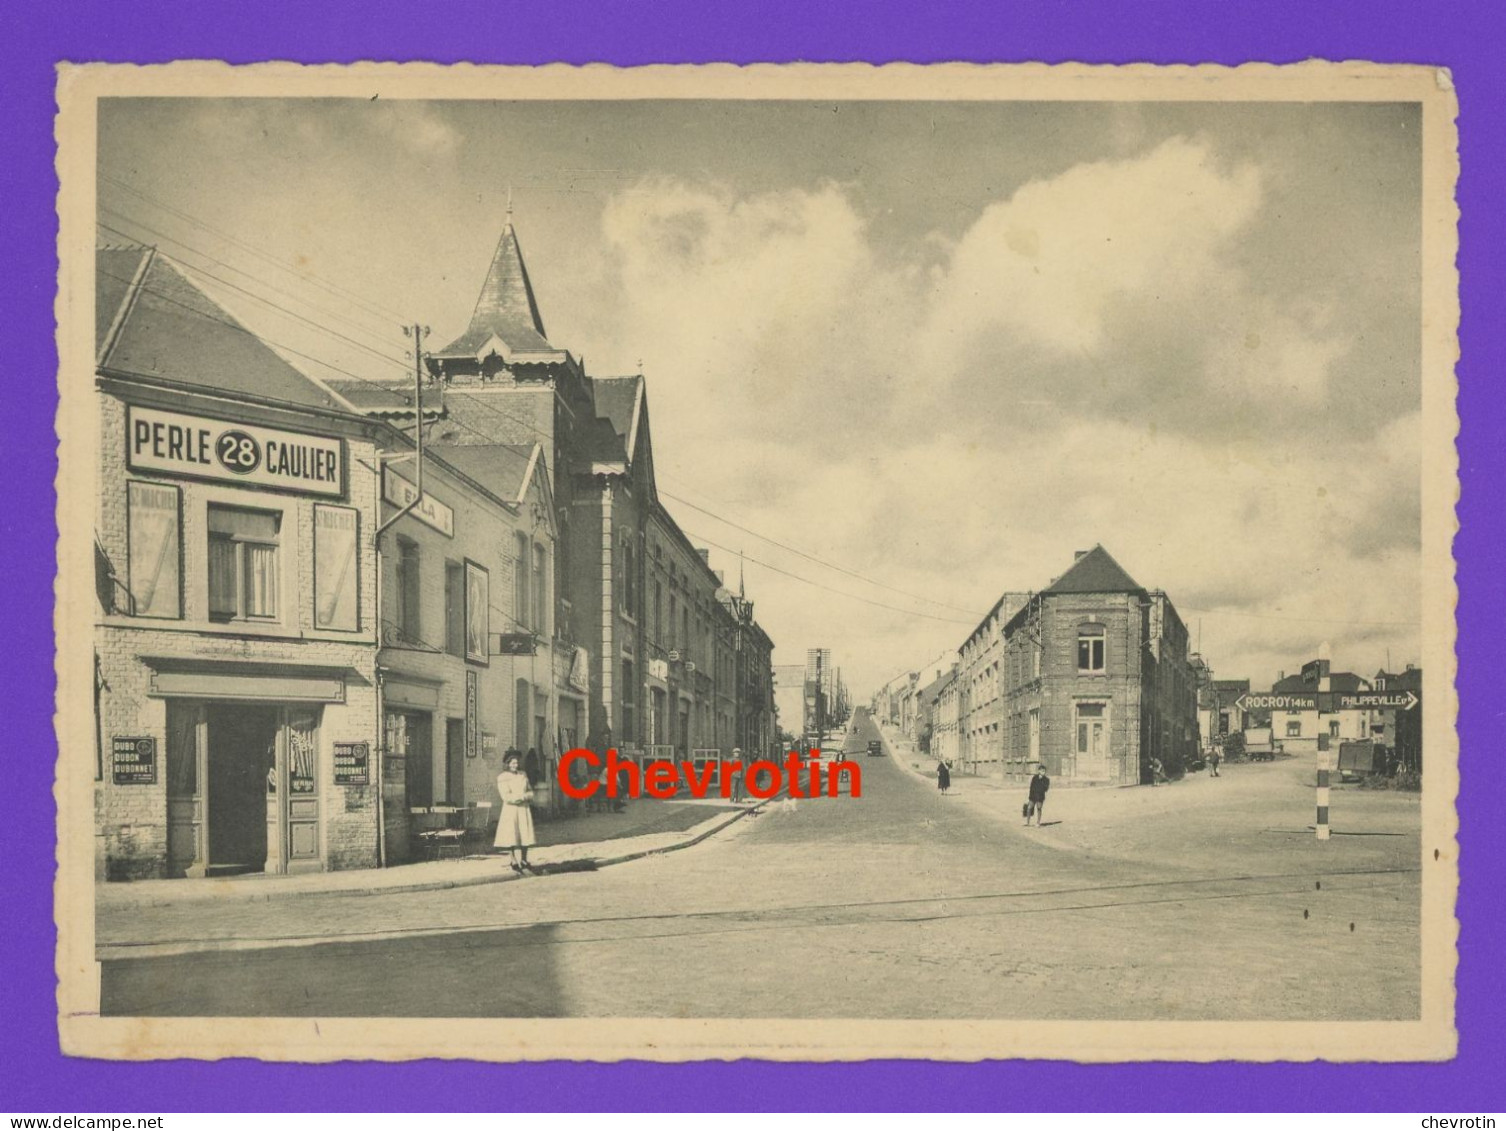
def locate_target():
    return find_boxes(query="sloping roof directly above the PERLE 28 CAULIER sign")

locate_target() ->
[95,247,349,411]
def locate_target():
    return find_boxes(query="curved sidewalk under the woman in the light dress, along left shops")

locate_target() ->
[95,798,767,915]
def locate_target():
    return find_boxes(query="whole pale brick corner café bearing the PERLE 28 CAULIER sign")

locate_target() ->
[93,247,380,879]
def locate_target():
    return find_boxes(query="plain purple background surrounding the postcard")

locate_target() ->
[0,0,1506,1113]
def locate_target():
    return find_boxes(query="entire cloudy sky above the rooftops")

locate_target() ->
[99,99,1422,696]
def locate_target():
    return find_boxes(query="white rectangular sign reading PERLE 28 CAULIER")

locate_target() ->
[125,405,345,498]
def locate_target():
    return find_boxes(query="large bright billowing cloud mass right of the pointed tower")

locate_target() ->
[569,137,1419,695]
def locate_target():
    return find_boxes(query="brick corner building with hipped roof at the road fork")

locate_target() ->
[1003,545,1197,785]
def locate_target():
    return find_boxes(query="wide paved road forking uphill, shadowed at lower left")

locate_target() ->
[102,718,1419,1020]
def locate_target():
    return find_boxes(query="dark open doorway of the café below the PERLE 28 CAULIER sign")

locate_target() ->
[208,703,282,875]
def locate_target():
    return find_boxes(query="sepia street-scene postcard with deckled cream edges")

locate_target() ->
[57,62,1458,1060]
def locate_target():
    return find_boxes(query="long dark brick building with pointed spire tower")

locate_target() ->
[412,218,773,758]
